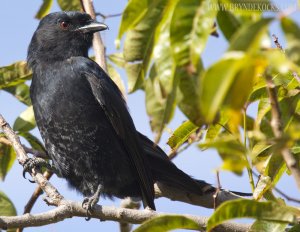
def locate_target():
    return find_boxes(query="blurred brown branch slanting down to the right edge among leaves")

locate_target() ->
[266,73,300,189]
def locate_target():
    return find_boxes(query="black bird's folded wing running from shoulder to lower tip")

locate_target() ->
[73,57,155,210]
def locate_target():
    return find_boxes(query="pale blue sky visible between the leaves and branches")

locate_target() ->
[0,0,300,232]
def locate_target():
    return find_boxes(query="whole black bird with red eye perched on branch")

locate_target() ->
[28,12,248,213]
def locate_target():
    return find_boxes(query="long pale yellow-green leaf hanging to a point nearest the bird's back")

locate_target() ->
[145,19,178,142]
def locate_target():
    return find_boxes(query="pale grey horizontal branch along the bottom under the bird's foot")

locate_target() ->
[0,201,250,232]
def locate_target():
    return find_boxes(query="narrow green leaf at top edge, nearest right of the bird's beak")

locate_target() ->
[116,0,149,44]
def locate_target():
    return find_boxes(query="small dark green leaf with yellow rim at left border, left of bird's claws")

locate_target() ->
[0,143,16,181]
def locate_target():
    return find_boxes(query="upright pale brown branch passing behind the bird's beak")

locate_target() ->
[81,0,107,72]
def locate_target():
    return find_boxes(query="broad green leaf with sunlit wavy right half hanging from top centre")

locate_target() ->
[170,0,217,67]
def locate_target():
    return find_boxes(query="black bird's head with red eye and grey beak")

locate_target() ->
[27,11,108,67]
